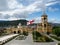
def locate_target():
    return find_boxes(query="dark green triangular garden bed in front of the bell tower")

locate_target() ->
[33,31,53,42]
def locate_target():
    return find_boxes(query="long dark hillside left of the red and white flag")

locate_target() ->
[0,19,27,27]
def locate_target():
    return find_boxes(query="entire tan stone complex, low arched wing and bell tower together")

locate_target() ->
[6,14,52,34]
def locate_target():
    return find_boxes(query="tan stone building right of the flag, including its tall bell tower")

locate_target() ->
[37,14,52,33]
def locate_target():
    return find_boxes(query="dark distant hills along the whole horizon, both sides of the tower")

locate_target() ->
[0,19,60,27]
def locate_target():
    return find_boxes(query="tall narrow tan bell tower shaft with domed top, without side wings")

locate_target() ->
[41,14,48,33]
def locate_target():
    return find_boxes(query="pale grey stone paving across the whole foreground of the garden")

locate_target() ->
[4,34,57,45]
